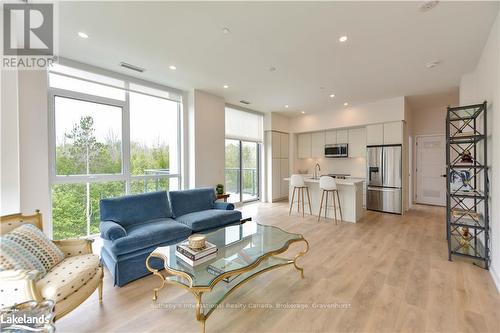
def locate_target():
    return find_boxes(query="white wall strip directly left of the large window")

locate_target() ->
[19,70,52,235]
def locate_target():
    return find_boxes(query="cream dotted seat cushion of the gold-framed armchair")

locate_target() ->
[36,254,100,302]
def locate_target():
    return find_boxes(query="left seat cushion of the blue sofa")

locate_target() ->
[111,219,191,255]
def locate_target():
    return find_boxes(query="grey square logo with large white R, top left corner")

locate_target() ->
[3,3,54,56]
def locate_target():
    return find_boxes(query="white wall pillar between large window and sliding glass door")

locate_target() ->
[189,90,225,187]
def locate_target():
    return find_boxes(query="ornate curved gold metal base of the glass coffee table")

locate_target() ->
[146,237,309,333]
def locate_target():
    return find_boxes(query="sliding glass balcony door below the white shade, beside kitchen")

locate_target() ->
[225,139,260,203]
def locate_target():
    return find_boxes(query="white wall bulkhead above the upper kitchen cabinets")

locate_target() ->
[290,97,405,133]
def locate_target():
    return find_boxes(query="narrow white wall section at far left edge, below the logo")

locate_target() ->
[0,70,21,215]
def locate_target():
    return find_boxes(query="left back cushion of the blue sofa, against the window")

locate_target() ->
[99,191,172,228]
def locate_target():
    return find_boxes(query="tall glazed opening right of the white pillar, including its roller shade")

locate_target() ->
[225,108,263,202]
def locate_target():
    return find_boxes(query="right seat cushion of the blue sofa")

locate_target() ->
[175,209,241,231]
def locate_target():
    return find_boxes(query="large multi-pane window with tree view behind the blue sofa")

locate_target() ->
[49,66,181,239]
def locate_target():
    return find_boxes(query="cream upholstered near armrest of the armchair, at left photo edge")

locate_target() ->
[0,269,43,307]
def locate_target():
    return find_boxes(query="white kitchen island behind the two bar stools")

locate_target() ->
[284,175,364,223]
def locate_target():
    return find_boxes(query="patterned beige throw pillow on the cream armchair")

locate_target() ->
[0,224,64,277]
